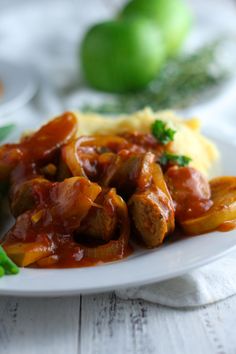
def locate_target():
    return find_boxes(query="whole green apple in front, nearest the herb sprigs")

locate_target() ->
[80,17,165,93]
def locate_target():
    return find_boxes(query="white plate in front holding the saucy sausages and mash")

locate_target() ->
[0,135,236,296]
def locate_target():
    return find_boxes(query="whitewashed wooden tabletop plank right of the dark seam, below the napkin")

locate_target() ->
[80,294,236,354]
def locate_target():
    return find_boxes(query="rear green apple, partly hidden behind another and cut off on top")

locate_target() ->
[121,0,192,56]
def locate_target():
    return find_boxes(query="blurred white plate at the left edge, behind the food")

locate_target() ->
[0,60,37,118]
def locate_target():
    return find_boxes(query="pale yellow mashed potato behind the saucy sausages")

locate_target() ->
[76,108,219,175]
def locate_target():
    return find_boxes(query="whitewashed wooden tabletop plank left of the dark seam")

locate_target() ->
[0,297,80,354]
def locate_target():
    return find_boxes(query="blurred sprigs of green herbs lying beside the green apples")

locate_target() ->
[82,41,227,114]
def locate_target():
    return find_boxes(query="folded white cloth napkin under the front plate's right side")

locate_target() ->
[116,252,236,307]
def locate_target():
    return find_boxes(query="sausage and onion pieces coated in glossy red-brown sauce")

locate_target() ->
[0,113,232,268]
